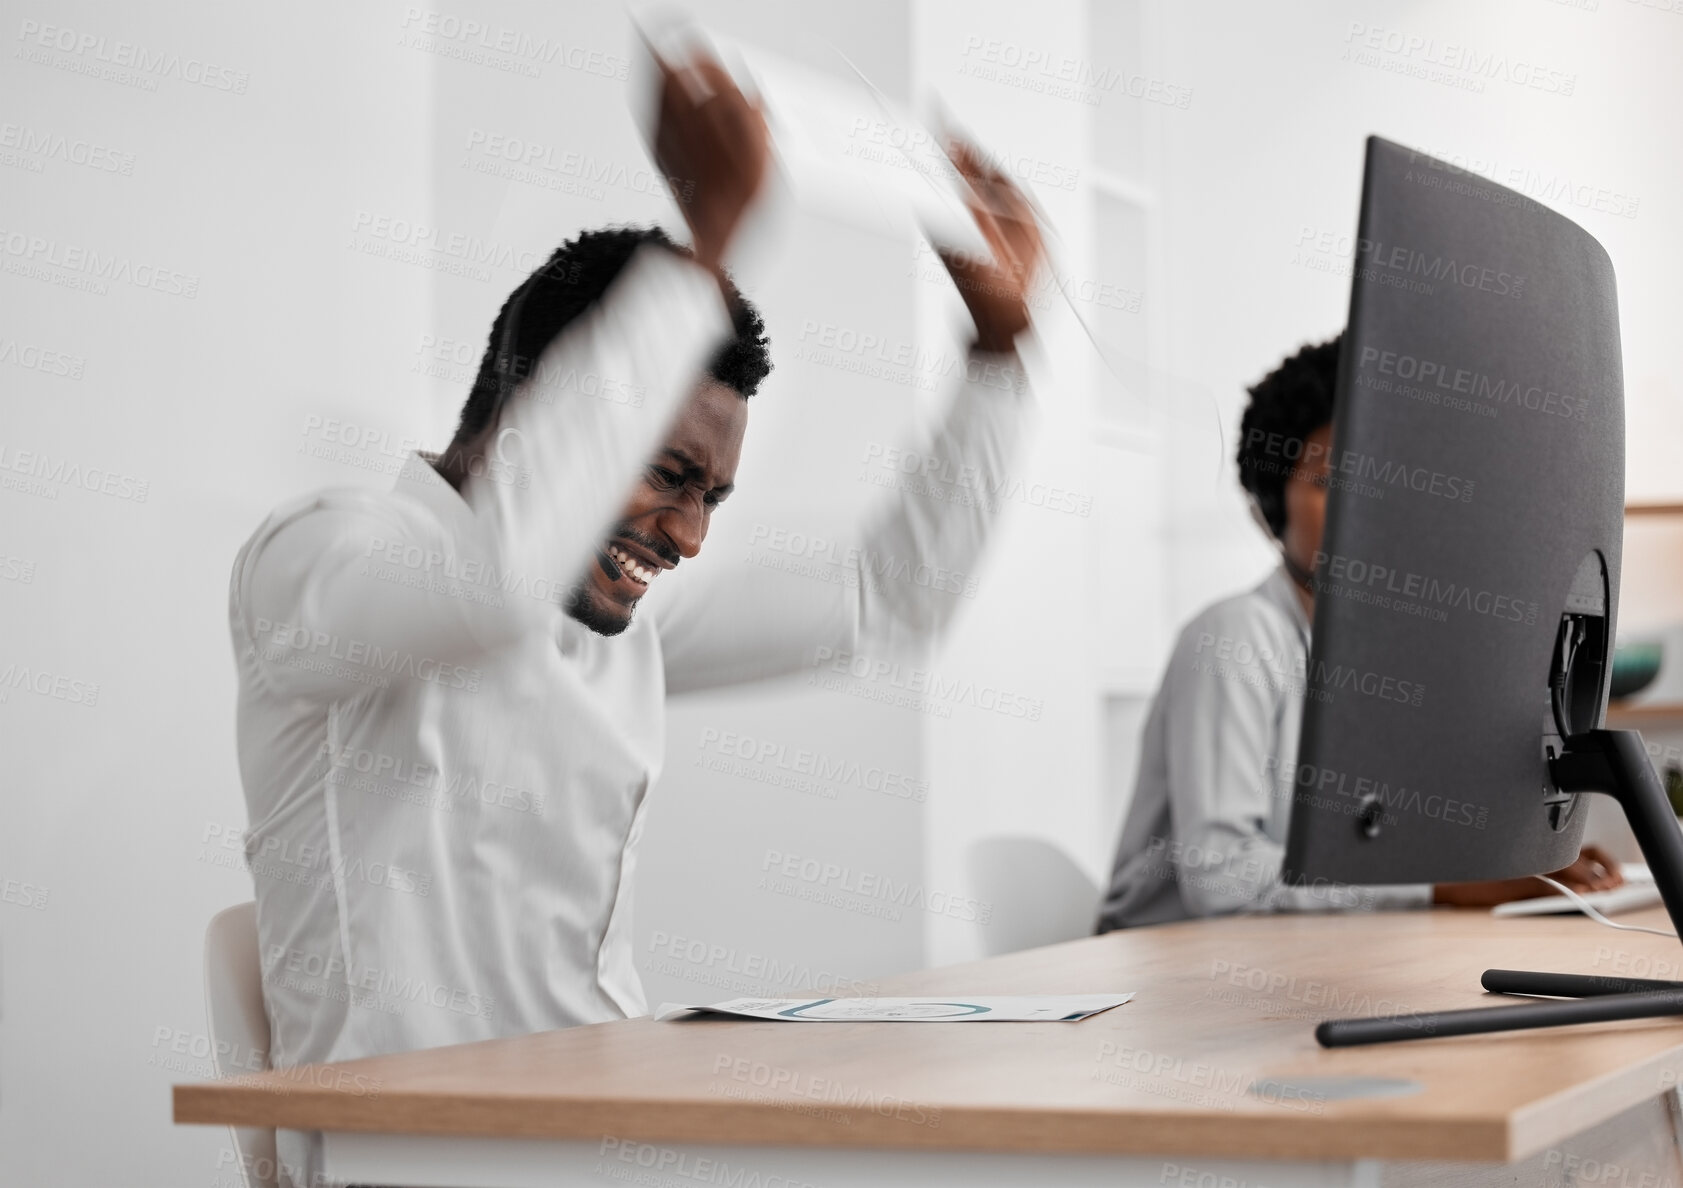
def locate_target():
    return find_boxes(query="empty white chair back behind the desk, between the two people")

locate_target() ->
[968,836,1099,957]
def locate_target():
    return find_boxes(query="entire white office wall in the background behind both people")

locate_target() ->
[0,0,1683,1186]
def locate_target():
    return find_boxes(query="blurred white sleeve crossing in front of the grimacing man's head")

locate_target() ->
[232,246,730,697]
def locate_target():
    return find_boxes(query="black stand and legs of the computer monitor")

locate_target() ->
[1314,730,1683,1048]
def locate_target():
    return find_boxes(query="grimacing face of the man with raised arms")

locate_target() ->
[567,379,747,636]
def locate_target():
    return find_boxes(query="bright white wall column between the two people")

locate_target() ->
[914,0,1106,964]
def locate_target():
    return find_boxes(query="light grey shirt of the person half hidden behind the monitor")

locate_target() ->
[1099,569,1432,932]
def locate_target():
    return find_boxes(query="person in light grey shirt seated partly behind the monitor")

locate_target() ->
[1097,338,1622,932]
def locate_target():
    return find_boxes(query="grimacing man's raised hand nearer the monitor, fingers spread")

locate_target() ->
[941,140,1045,352]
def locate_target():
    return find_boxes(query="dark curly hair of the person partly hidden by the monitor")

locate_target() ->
[1239,333,1343,537]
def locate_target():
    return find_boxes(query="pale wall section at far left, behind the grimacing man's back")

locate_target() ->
[0,3,433,1185]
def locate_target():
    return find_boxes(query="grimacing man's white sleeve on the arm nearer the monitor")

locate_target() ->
[655,353,1033,693]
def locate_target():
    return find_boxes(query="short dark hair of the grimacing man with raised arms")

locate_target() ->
[456,227,771,439]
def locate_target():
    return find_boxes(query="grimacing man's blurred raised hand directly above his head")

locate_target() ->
[650,49,771,273]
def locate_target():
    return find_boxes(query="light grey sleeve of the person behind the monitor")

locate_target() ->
[1163,599,1431,915]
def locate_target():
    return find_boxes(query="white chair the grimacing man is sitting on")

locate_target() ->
[205,904,279,1188]
